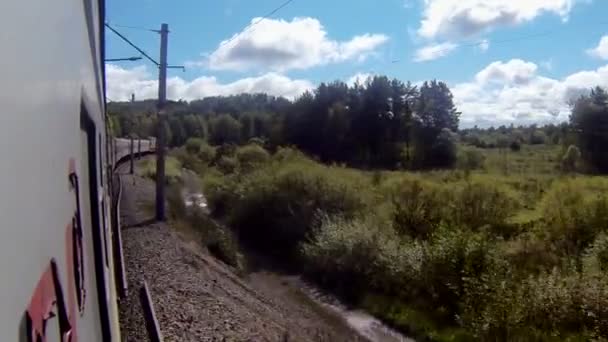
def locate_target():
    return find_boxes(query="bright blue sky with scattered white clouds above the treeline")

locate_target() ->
[107,0,608,126]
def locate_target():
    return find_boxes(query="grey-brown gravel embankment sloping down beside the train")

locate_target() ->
[116,162,366,342]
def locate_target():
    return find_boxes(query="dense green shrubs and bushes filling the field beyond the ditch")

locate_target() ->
[195,150,608,341]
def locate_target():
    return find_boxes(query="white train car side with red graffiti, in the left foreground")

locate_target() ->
[0,0,134,342]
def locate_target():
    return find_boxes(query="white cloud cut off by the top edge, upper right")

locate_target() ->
[418,0,582,38]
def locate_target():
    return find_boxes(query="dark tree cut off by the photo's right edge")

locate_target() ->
[570,87,608,173]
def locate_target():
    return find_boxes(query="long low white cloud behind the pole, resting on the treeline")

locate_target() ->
[106,64,314,101]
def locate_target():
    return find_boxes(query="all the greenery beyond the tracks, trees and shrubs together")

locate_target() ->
[108,77,608,341]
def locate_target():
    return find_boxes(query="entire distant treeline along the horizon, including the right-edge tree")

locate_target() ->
[108,76,608,172]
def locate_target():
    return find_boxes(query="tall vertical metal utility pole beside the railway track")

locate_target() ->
[156,24,169,221]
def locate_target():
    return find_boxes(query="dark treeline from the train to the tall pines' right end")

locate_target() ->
[108,76,459,169]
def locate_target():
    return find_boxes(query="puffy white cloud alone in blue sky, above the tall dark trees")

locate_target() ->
[206,17,388,72]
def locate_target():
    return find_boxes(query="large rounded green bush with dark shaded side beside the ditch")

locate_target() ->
[230,161,365,252]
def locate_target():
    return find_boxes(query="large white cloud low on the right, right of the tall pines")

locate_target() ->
[451,59,608,127]
